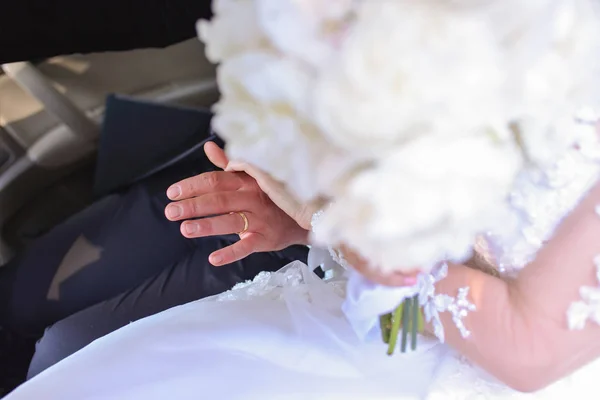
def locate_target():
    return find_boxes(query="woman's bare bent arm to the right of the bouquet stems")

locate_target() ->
[428,180,600,391]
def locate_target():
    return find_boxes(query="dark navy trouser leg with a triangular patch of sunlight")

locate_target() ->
[0,186,194,337]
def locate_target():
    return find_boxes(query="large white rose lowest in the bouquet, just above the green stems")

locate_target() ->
[315,135,521,271]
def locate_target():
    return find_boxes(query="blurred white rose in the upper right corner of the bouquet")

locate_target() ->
[504,0,600,168]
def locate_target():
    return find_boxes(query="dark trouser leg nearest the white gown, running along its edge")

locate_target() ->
[28,238,308,378]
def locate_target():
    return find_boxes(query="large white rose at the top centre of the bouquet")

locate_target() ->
[314,0,511,152]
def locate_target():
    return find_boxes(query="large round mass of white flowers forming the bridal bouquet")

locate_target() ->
[198,0,600,350]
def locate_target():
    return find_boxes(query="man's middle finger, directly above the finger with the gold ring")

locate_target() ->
[165,191,262,221]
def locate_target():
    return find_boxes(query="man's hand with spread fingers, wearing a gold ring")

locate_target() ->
[165,143,308,266]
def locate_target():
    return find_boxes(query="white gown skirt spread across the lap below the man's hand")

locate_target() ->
[7,262,448,400]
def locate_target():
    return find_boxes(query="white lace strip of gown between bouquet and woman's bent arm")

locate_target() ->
[485,115,600,275]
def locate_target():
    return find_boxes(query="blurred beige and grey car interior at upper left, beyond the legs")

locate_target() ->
[0,39,218,266]
